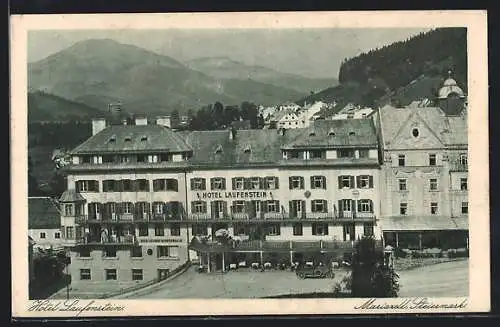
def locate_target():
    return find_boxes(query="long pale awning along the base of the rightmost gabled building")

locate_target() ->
[379,216,469,231]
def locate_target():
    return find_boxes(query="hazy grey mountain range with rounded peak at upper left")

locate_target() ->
[28,39,336,119]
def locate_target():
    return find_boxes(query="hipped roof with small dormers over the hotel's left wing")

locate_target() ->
[72,125,191,154]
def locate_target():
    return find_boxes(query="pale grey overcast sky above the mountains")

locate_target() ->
[28,28,429,78]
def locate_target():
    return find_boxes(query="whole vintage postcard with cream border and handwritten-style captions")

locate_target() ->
[11,11,490,317]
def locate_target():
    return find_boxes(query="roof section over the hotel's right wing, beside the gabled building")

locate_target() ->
[285,119,377,148]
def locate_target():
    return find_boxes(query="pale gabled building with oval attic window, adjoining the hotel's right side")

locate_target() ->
[377,75,469,248]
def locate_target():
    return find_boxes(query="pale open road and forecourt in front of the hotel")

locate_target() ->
[136,261,468,299]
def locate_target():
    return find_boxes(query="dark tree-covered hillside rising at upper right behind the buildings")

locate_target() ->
[297,28,467,106]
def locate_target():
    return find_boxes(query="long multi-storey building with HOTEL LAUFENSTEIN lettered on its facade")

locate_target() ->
[61,120,381,284]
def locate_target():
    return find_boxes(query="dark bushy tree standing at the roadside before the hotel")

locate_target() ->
[351,237,399,298]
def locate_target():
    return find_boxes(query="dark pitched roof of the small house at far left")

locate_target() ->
[28,197,61,229]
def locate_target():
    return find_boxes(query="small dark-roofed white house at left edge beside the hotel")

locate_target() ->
[28,197,62,250]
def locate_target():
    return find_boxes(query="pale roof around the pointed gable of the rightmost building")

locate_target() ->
[379,105,468,147]
